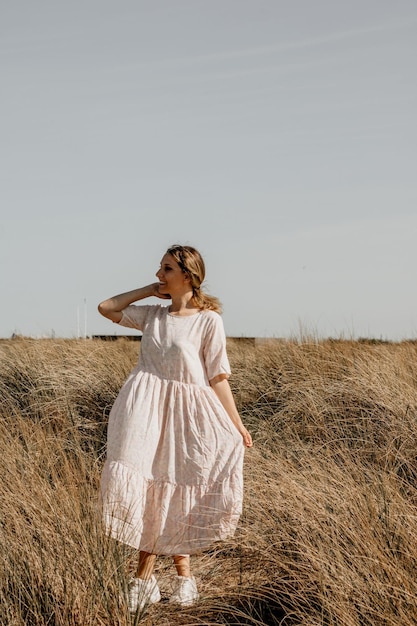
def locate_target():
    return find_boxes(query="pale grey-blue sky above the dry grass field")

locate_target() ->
[0,0,417,339]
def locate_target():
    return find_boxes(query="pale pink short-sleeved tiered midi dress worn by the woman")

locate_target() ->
[101,305,244,554]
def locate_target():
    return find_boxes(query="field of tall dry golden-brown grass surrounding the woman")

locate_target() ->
[0,337,417,626]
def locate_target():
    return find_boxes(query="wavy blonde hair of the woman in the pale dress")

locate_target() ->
[167,244,222,313]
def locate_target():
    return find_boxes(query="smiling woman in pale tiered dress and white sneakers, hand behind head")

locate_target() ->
[98,245,252,612]
